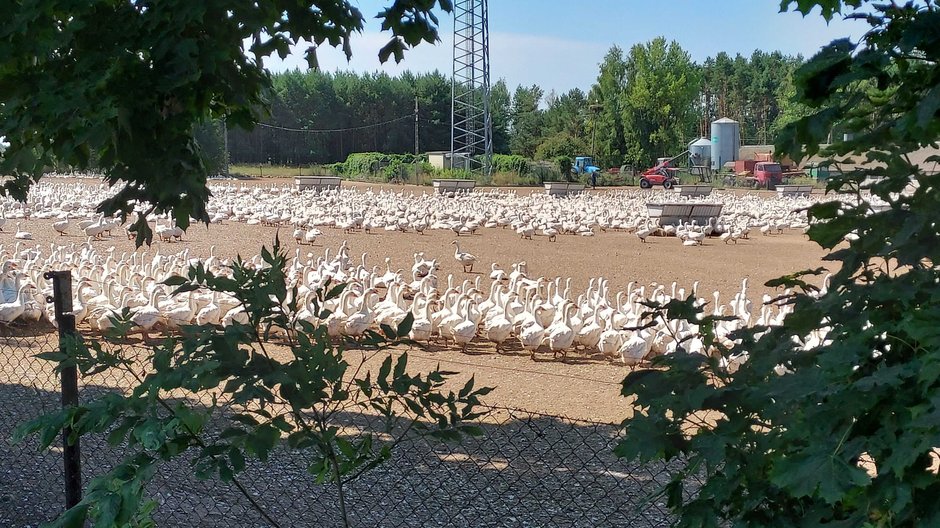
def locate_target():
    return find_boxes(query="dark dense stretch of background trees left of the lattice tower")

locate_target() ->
[229,70,451,165]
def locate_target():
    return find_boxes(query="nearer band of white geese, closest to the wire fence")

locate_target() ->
[0,242,824,365]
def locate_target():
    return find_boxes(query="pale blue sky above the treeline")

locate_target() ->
[266,0,866,93]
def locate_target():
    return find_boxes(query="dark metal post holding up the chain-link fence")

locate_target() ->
[43,271,82,509]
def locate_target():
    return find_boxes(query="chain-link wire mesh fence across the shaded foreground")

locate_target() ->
[0,327,696,528]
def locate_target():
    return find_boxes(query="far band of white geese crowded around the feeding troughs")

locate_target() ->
[14,180,821,245]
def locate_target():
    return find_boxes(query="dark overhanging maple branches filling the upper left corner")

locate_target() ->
[0,0,451,243]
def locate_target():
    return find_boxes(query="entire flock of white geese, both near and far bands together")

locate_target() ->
[0,182,844,365]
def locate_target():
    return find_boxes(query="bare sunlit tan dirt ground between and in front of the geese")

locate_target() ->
[0,176,824,422]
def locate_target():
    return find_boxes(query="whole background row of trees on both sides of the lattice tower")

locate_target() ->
[229,37,802,166]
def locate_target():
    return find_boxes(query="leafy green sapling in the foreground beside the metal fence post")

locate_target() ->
[16,243,489,527]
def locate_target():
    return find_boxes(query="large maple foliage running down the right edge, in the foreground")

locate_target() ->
[617,0,940,528]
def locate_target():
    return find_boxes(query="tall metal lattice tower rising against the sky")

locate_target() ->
[450,0,493,179]
